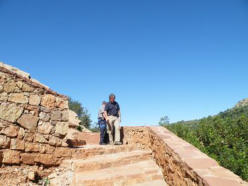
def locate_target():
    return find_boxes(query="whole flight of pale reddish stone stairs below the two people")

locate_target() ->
[50,145,166,186]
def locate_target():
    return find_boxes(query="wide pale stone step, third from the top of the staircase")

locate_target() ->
[72,159,166,186]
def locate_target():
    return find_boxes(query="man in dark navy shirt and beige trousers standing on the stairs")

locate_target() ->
[104,94,122,145]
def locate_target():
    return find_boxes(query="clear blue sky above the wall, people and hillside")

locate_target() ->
[0,0,248,125]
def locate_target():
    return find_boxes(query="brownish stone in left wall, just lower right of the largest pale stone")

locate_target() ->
[17,114,39,131]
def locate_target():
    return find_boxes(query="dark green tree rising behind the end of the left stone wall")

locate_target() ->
[69,98,92,128]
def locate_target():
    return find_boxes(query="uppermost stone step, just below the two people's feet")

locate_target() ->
[72,145,140,159]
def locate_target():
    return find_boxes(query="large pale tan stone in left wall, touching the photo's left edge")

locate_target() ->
[0,103,23,122]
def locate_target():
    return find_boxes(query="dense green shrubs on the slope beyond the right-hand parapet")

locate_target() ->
[166,106,248,180]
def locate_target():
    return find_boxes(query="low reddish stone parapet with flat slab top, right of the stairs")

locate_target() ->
[122,126,248,186]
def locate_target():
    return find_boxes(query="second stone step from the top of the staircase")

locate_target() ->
[70,150,152,172]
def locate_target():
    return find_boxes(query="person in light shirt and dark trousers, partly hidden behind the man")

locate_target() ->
[98,101,107,145]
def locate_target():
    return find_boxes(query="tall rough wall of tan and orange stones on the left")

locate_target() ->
[0,63,79,166]
